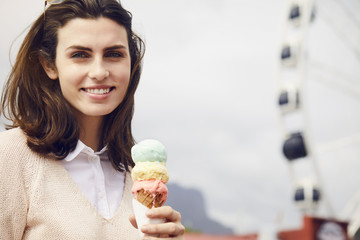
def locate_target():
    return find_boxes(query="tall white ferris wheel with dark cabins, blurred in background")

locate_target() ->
[277,0,360,239]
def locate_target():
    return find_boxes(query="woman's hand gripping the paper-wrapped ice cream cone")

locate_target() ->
[129,206,185,240]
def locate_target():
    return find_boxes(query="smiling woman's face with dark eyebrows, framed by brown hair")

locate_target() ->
[47,18,131,123]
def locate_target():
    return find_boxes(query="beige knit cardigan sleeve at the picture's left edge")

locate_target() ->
[0,129,30,240]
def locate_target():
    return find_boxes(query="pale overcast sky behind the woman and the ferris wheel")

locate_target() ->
[0,0,360,233]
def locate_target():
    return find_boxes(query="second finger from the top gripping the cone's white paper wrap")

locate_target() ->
[141,222,185,237]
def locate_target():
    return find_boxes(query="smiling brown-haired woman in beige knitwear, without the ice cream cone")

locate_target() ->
[0,0,184,240]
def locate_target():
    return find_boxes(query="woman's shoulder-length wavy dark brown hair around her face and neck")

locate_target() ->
[0,0,145,171]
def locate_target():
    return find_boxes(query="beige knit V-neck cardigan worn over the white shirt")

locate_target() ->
[0,128,139,240]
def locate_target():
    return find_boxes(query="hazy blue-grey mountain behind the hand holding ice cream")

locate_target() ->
[166,183,233,234]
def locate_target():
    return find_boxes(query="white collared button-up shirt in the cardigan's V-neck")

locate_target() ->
[61,140,125,219]
